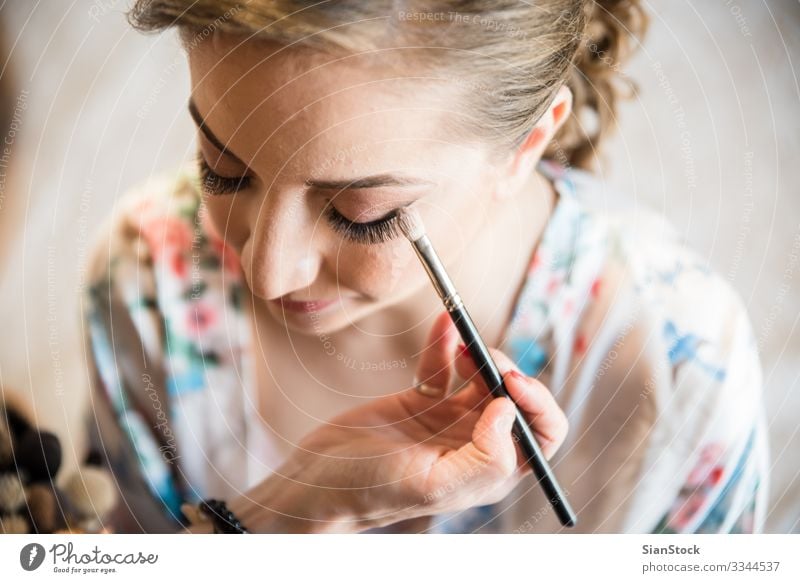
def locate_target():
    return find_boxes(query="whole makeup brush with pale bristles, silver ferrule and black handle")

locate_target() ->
[395,205,577,526]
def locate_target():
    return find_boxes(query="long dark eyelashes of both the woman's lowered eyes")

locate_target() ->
[197,154,400,245]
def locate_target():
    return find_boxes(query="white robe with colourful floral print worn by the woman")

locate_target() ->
[84,161,768,533]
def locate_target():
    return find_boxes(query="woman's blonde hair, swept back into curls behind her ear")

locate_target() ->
[128,0,647,168]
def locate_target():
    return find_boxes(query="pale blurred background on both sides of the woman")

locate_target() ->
[0,0,800,532]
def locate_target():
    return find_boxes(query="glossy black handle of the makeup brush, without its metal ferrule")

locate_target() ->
[448,302,578,526]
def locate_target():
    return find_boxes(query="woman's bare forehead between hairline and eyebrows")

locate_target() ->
[189,35,451,178]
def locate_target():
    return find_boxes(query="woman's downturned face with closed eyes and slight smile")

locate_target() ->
[189,35,506,334]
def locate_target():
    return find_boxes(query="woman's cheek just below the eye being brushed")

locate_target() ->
[338,238,418,300]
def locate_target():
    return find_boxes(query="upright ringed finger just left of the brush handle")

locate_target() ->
[414,312,459,397]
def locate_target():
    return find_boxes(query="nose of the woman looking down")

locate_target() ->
[242,197,322,300]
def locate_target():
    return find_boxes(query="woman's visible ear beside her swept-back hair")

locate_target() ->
[495,85,572,200]
